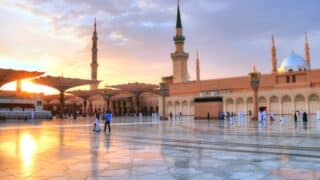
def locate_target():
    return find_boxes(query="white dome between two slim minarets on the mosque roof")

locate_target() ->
[278,52,308,72]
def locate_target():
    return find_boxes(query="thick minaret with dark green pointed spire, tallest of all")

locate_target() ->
[171,0,189,83]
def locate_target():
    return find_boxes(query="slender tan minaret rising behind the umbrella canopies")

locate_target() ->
[91,19,98,90]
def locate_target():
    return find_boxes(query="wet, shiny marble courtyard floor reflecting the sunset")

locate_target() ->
[0,118,320,180]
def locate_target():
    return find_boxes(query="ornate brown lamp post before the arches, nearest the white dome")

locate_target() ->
[249,66,261,120]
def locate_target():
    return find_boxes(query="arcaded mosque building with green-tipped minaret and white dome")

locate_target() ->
[158,4,320,118]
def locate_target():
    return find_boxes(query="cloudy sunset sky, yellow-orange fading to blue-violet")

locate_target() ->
[0,0,320,93]
